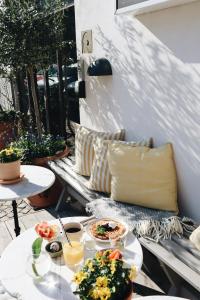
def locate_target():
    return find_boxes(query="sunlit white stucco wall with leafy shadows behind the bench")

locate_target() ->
[75,0,200,221]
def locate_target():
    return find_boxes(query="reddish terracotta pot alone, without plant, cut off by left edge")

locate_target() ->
[0,122,14,150]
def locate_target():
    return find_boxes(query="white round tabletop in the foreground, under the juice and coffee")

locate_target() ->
[0,217,143,300]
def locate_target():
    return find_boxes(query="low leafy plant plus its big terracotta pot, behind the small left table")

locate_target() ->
[13,133,69,207]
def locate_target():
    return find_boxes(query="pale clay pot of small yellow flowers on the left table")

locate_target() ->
[0,147,22,183]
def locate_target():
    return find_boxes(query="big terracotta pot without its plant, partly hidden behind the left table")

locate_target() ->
[28,147,70,208]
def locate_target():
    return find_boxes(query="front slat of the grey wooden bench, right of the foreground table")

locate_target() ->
[139,238,200,292]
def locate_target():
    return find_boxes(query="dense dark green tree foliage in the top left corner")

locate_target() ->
[0,0,65,70]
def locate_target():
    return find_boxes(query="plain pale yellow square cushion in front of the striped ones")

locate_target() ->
[108,143,178,212]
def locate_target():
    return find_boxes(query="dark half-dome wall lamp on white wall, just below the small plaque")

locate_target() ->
[87,58,112,76]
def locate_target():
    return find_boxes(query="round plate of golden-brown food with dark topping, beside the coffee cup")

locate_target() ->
[86,218,129,243]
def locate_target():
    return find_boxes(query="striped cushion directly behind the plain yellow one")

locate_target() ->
[87,137,152,193]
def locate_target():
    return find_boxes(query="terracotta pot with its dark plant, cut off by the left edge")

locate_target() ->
[0,110,19,149]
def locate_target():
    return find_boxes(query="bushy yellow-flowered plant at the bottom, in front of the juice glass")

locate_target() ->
[74,249,136,300]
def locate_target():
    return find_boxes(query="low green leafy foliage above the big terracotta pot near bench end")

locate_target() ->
[12,133,66,163]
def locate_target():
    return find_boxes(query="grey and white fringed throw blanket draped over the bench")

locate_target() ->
[86,198,194,242]
